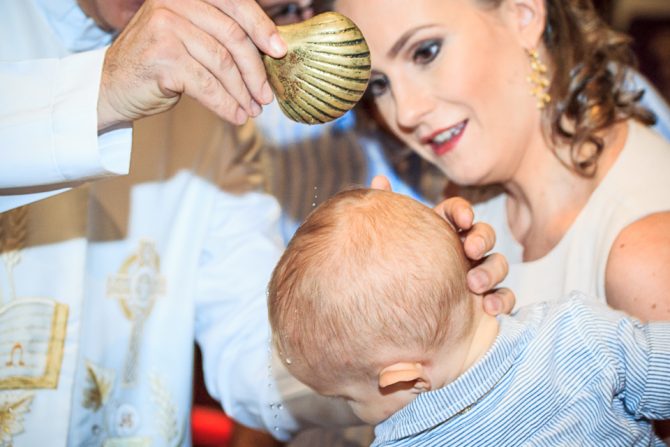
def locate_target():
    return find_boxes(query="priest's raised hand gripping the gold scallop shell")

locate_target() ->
[98,0,286,130]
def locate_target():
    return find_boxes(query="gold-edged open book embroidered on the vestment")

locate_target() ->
[0,298,68,390]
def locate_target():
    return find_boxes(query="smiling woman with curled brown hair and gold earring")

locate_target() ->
[320,0,670,320]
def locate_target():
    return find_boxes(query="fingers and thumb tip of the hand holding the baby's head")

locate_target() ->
[370,175,516,315]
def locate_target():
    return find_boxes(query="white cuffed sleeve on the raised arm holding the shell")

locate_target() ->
[0,49,132,212]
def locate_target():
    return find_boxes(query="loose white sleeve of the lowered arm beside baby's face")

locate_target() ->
[195,192,297,440]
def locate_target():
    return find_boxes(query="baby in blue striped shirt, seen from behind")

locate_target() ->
[269,189,670,446]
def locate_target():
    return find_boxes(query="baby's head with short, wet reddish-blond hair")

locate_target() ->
[269,189,479,423]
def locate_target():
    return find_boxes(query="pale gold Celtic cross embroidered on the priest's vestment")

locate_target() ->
[107,241,165,386]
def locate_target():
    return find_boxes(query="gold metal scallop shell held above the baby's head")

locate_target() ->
[263,12,371,124]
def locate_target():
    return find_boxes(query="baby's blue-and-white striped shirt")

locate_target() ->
[373,293,670,447]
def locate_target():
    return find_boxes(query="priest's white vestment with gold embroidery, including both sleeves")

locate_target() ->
[0,0,302,446]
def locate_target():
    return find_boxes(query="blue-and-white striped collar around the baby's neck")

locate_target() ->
[375,316,532,444]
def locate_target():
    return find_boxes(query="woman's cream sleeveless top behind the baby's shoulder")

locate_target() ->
[475,121,670,307]
